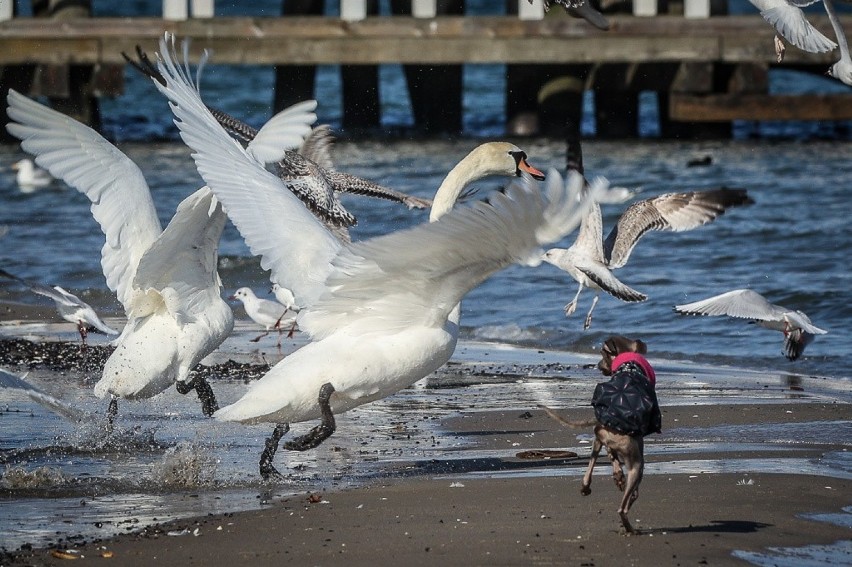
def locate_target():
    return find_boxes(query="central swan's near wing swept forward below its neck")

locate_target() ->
[299,170,605,338]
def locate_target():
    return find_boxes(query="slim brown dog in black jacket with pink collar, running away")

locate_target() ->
[580,336,662,533]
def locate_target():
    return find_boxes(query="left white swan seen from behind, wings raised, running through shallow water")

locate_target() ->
[2,90,316,423]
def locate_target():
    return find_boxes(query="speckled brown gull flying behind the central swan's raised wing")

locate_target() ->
[122,45,431,241]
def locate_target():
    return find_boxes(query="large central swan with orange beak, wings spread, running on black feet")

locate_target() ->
[150,33,606,478]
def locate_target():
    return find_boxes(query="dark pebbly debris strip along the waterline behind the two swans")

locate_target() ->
[0,339,270,382]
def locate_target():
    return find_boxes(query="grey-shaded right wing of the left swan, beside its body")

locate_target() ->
[128,187,226,325]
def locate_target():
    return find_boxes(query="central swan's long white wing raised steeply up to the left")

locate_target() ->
[155,34,342,305]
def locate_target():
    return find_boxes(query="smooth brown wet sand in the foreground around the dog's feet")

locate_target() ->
[3,404,852,566]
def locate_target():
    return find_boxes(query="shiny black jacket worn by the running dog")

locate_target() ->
[592,362,663,437]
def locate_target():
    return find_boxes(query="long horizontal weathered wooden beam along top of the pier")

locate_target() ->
[0,15,852,65]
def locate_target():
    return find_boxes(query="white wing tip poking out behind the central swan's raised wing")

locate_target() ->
[246,100,317,163]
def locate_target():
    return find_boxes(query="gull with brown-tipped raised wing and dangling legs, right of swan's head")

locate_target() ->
[543,188,753,330]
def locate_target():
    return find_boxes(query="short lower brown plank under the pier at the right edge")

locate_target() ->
[669,93,852,122]
